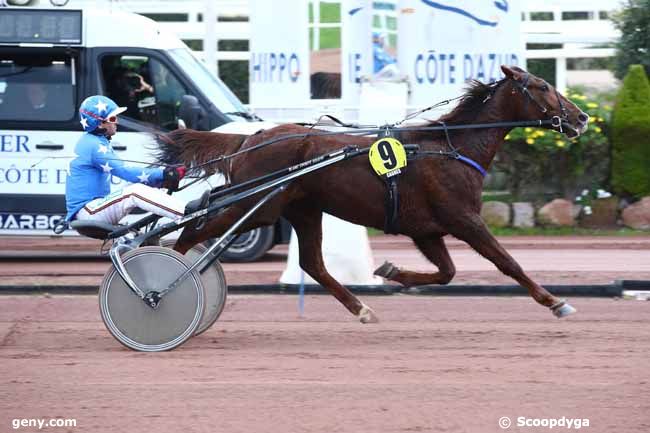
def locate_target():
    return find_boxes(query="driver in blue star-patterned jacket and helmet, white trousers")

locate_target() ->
[65,95,210,225]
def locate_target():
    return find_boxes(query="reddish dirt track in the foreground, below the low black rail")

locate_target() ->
[0,295,650,433]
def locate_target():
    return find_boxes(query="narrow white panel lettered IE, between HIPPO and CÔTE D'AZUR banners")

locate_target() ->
[341,0,372,106]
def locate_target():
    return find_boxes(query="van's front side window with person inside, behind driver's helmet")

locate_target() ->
[101,55,188,130]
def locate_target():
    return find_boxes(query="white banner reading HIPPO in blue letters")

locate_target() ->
[249,0,310,107]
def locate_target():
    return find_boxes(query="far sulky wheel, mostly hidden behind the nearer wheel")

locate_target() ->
[162,240,228,335]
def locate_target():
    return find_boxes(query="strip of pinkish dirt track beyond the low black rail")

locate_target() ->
[0,236,650,286]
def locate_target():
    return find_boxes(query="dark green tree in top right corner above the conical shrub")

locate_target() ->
[612,0,650,80]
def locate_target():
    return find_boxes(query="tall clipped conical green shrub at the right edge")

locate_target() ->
[612,65,650,198]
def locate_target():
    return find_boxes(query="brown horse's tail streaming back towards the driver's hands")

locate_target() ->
[155,129,246,172]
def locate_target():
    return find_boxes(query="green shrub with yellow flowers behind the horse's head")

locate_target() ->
[493,88,612,202]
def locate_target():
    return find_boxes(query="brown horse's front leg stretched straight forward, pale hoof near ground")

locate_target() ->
[452,214,576,317]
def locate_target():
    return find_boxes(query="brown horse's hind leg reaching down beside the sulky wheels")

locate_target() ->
[285,204,378,323]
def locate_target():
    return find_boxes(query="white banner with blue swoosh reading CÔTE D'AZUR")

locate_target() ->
[398,0,525,106]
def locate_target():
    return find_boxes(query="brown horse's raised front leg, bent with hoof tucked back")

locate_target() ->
[375,236,456,287]
